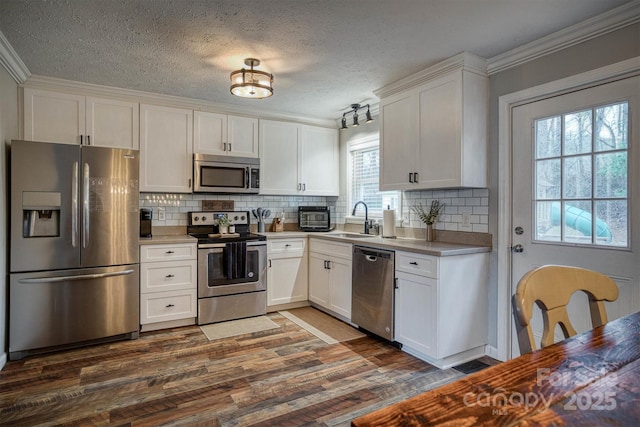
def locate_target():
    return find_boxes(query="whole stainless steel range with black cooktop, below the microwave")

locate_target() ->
[187,211,267,325]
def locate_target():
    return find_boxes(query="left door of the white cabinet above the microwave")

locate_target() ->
[193,111,228,156]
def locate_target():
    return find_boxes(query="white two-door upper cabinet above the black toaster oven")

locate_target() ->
[260,120,339,196]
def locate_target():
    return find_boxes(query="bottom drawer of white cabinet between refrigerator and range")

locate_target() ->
[140,289,197,325]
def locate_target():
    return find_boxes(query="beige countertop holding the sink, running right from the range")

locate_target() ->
[260,231,491,256]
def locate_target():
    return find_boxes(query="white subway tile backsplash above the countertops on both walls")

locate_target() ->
[140,188,489,233]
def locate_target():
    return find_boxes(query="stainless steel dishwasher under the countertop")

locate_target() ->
[351,246,395,341]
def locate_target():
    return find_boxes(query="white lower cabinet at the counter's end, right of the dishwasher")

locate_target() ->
[395,251,489,369]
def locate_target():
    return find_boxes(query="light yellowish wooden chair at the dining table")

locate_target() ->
[513,265,618,354]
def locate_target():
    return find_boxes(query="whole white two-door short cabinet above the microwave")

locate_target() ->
[193,111,258,157]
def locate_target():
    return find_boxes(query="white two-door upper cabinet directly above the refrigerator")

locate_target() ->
[24,88,140,150]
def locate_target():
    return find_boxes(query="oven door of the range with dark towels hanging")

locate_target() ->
[198,242,267,298]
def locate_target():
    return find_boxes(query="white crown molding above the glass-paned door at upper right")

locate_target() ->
[487,0,640,75]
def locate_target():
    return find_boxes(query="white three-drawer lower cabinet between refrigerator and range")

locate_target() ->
[140,243,198,331]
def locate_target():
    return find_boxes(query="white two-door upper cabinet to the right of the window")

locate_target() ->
[376,53,488,190]
